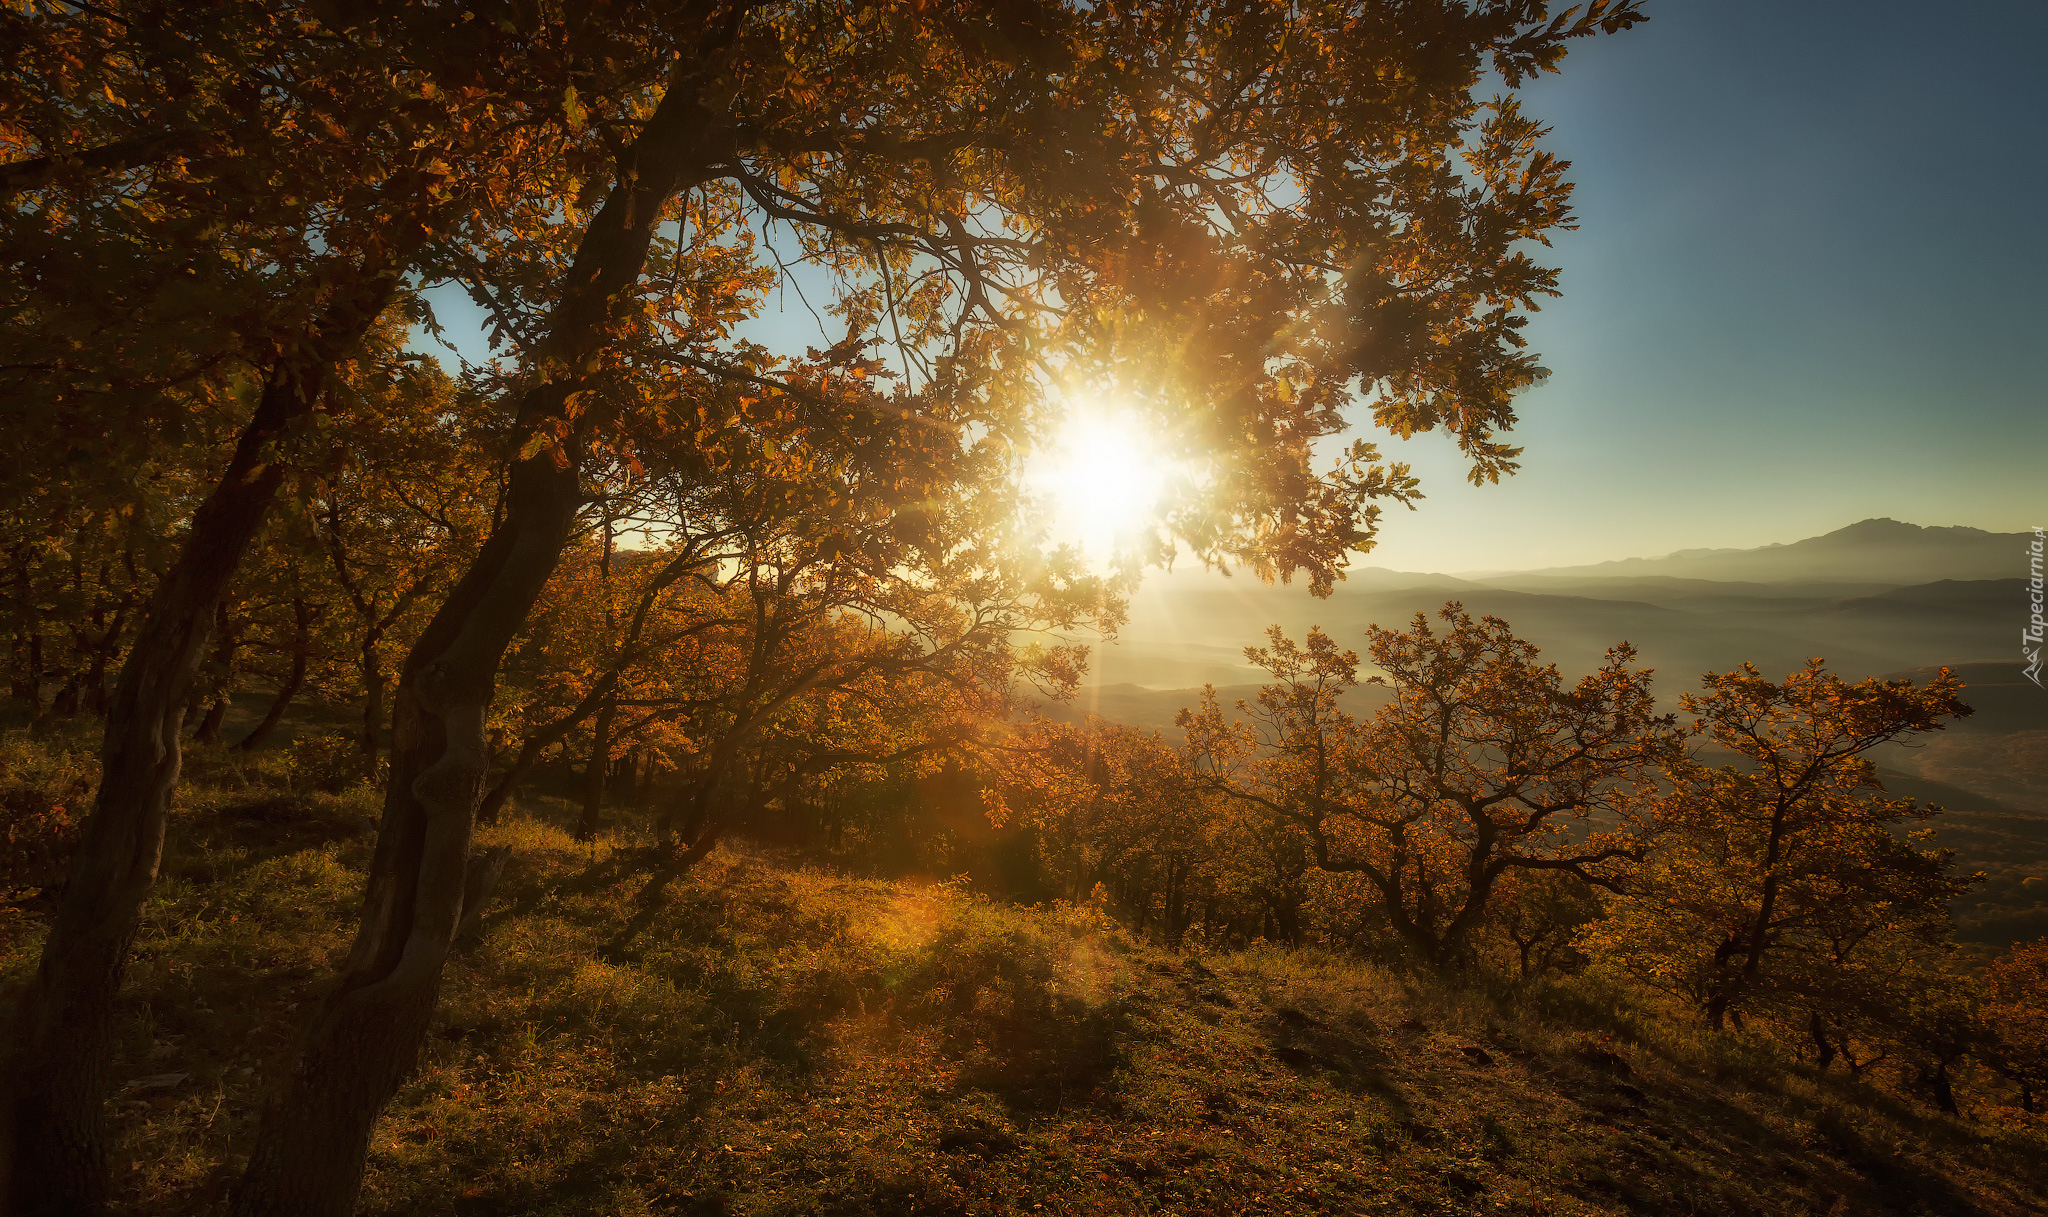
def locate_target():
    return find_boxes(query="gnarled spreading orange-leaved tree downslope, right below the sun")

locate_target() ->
[1182,602,1677,965]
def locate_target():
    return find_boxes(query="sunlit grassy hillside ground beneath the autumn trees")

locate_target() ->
[0,733,2048,1217]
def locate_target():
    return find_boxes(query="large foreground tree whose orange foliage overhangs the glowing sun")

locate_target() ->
[242,4,1636,1180]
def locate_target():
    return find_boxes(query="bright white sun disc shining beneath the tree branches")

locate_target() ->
[1030,404,1171,563]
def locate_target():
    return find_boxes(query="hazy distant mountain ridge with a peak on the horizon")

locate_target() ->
[1485,518,2032,586]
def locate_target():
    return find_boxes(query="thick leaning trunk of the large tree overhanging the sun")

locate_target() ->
[233,80,721,1217]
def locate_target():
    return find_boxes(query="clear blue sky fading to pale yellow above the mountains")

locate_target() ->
[419,0,2048,572]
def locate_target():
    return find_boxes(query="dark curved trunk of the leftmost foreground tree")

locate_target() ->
[0,275,397,1217]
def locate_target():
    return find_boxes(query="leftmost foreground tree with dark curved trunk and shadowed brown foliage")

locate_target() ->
[0,4,588,1213]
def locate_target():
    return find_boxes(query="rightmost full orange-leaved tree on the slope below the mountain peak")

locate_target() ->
[1602,660,1970,1029]
